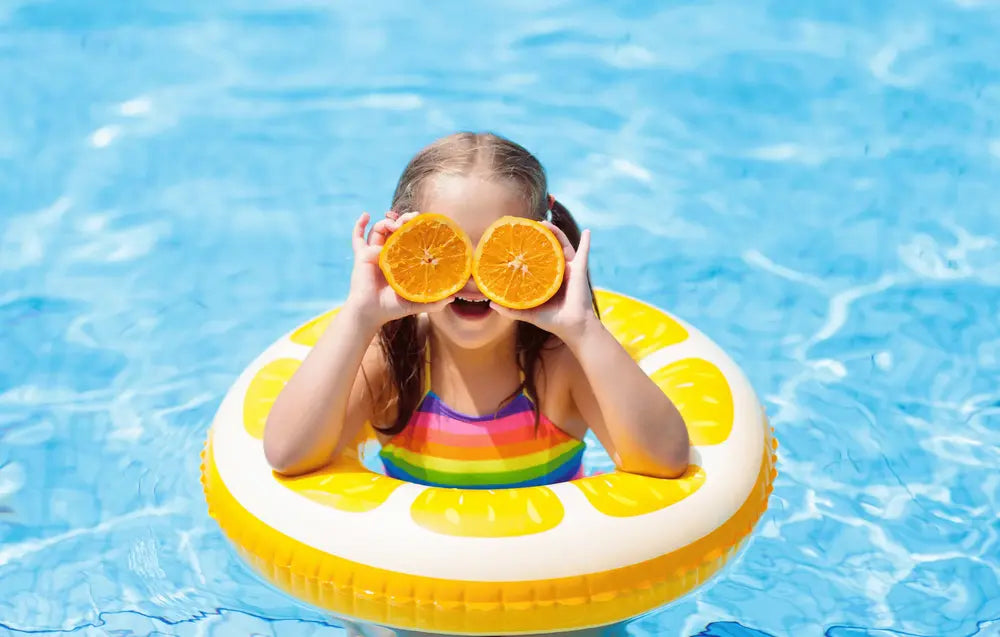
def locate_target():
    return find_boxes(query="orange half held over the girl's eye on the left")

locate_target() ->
[378,212,472,303]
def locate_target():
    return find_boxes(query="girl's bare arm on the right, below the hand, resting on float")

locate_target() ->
[564,315,691,478]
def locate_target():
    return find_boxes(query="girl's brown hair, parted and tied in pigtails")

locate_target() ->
[376,133,598,435]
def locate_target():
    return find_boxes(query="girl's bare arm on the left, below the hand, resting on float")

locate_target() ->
[264,305,384,475]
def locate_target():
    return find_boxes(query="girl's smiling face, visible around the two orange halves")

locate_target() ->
[421,175,529,349]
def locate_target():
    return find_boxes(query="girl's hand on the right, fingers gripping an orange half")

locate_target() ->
[490,221,598,341]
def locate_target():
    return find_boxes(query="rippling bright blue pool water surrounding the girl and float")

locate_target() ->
[0,0,1000,637]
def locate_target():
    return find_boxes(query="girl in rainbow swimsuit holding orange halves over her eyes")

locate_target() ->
[264,133,689,488]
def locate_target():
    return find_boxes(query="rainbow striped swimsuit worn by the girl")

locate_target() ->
[379,345,585,489]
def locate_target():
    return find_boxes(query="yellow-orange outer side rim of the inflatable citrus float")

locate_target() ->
[201,290,777,634]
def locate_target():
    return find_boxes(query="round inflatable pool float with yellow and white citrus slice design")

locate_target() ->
[202,291,777,635]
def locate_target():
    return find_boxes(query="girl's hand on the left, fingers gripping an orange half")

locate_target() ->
[344,212,451,327]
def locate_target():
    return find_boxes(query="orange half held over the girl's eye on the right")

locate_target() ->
[472,217,566,310]
